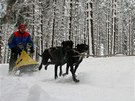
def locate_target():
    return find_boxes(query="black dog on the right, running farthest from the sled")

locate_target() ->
[63,44,89,82]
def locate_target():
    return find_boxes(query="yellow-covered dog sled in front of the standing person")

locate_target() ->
[12,51,38,74]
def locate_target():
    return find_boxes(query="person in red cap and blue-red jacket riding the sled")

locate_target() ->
[8,24,34,72]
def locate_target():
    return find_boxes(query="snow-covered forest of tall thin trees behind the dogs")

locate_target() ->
[0,0,135,63]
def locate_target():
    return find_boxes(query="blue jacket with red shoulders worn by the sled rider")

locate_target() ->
[8,31,33,50]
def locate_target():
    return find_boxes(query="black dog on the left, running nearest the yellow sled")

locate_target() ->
[39,41,73,79]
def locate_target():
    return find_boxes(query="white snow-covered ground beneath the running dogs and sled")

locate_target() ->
[0,57,135,101]
